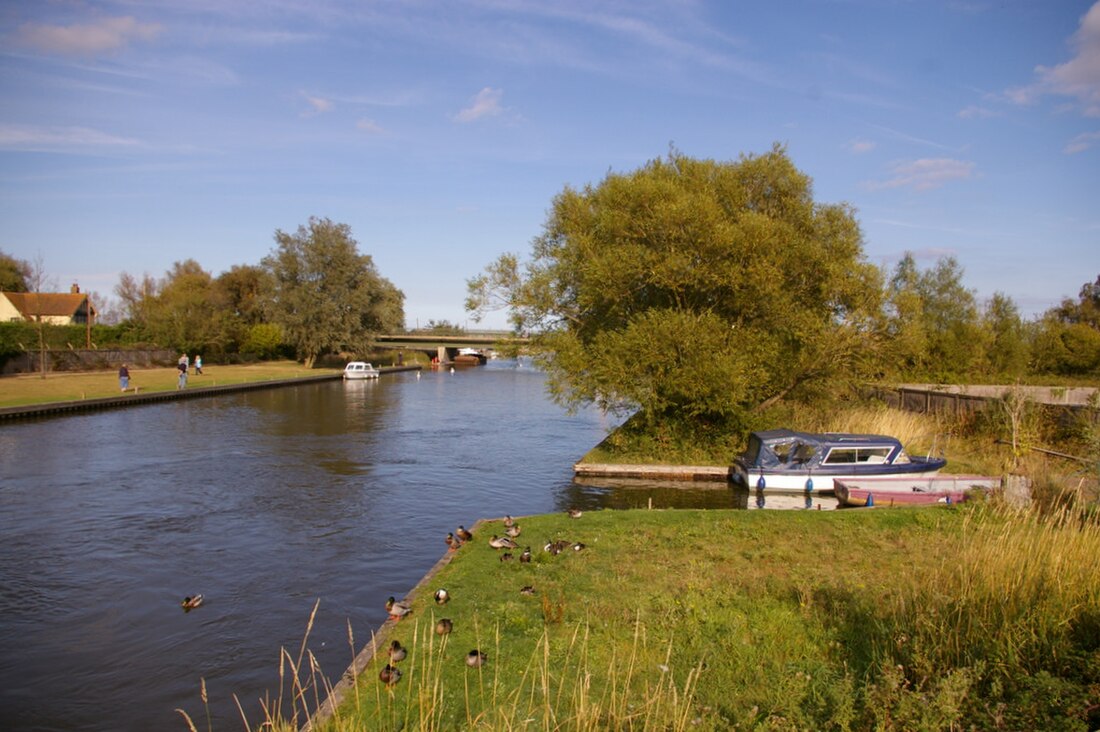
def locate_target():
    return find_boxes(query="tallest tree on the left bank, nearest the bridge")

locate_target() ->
[263,217,405,368]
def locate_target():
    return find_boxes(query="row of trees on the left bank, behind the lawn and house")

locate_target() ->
[0,218,405,367]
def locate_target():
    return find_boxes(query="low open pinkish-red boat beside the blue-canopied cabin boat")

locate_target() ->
[833,474,1001,506]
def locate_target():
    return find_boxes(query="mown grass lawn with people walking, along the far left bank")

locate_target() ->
[0,361,338,407]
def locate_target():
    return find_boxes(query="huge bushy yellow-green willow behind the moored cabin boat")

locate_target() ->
[466,145,881,423]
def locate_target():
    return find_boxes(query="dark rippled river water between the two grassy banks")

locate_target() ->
[0,361,748,730]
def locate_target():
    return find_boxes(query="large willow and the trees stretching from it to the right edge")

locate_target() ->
[466,145,1100,426]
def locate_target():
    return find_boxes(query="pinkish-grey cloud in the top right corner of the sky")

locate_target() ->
[1004,2,1100,117]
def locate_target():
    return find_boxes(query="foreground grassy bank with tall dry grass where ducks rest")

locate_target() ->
[249,505,1100,731]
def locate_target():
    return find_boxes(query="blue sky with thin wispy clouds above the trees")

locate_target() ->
[0,0,1100,327]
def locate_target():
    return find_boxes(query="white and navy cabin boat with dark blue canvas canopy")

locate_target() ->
[730,429,947,493]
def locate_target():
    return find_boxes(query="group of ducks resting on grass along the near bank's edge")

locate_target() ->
[378,509,585,687]
